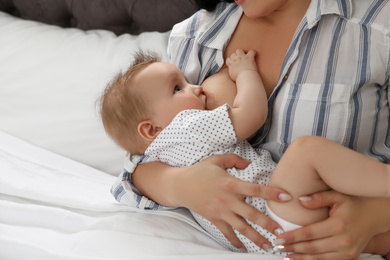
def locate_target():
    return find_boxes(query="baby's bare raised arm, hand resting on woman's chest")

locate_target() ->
[226,49,268,141]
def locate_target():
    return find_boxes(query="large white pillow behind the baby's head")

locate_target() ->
[0,12,169,175]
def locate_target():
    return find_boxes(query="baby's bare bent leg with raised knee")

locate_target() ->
[267,136,390,228]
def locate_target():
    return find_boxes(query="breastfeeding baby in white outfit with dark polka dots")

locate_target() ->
[101,50,390,253]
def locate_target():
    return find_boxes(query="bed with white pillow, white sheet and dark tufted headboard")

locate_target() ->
[0,0,382,260]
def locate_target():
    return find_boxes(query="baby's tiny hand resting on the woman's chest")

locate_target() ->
[226,49,257,81]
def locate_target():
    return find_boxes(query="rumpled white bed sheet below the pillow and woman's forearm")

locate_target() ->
[0,131,382,260]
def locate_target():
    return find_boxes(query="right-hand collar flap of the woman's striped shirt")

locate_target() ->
[306,0,352,28]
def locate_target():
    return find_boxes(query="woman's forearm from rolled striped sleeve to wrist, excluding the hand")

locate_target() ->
[132,162,182,207]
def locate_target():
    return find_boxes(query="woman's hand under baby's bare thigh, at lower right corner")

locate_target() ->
[278,191,390,260]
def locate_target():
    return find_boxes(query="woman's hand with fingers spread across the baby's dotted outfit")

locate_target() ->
[173,154,289,251]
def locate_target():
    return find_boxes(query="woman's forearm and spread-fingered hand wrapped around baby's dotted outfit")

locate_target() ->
[133,154,289,249]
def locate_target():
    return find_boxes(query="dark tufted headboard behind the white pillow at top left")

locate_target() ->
[0,0,196,35]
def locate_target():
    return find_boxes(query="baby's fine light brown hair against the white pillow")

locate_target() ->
[99,51,160,154]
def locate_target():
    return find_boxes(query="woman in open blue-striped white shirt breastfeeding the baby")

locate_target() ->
[118,0,390,259]
